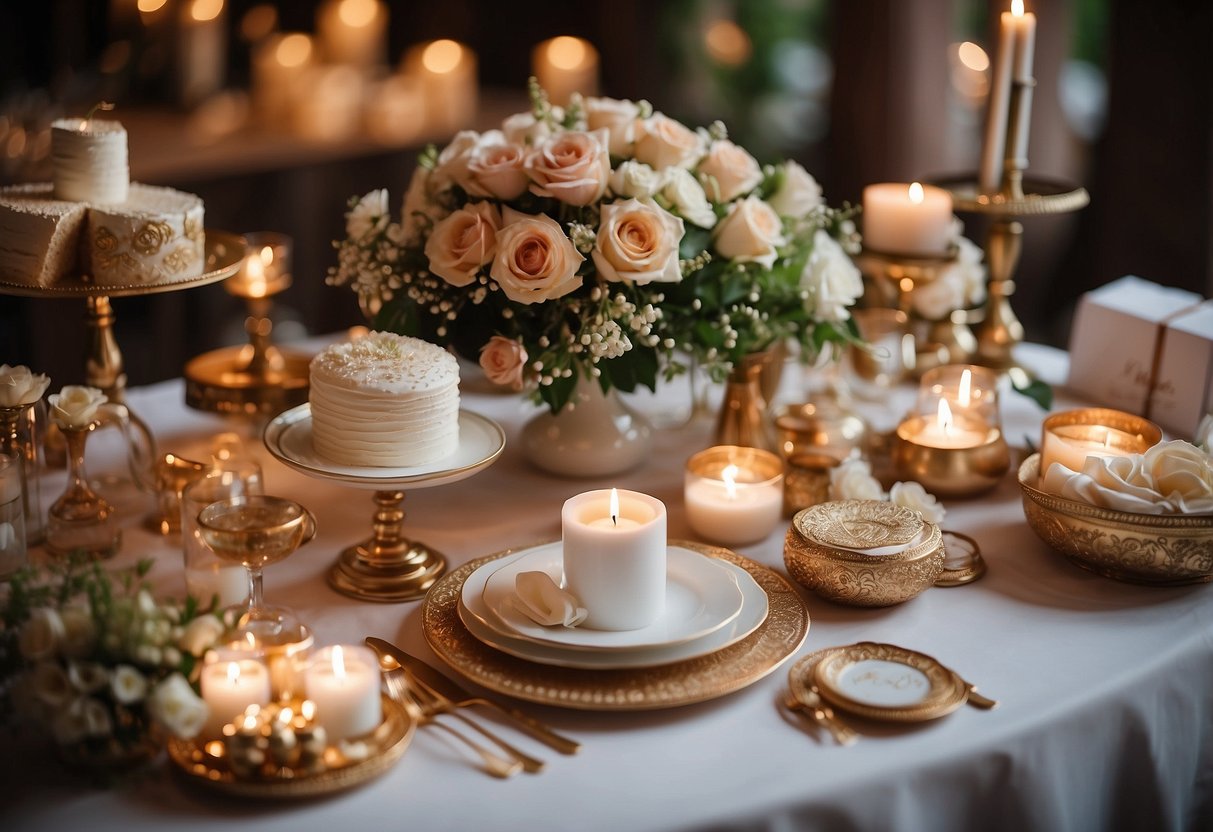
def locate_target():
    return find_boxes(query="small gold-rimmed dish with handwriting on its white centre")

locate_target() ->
[805,642,969,722]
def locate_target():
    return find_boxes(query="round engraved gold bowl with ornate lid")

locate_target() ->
[784,500,944,606]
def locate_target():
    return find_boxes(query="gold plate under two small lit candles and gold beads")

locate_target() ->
[169,696,417,799]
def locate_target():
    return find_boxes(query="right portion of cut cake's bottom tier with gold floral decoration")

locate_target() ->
[85,183,206,286]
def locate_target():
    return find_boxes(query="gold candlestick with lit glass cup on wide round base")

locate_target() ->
[184,232,311,416]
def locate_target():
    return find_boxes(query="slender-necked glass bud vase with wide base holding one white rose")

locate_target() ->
[46,422,123,558]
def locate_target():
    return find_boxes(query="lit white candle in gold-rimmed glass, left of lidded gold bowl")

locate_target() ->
[683,465,784,546]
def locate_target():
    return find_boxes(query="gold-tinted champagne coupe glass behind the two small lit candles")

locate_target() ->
[198,495,315,644]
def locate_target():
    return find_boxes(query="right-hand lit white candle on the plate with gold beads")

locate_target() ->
[304,644,383,741]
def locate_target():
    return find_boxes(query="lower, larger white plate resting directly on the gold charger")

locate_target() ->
[459,555,769,669]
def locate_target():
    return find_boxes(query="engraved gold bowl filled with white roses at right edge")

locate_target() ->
[1019,454,1213,586]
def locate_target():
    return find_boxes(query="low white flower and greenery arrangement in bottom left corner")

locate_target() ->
[0,559,226,759]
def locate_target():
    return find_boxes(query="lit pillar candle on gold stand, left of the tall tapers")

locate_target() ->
[864,182,952,256]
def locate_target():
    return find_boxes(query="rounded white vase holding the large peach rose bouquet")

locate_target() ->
[522,378,653,477]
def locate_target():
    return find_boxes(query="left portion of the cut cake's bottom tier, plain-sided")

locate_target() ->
[0,182,89,289]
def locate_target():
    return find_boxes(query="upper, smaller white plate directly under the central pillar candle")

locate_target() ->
[482,541,742,650]
